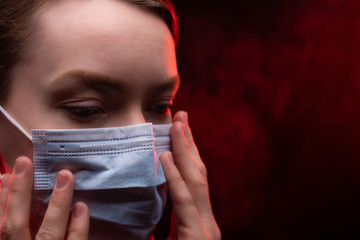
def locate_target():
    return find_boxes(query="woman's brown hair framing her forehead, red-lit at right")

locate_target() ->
[0,0,179,104]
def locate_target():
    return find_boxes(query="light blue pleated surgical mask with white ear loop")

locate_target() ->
[0,106,171,240]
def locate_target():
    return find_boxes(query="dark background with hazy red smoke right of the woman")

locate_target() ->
[174,0,360,239]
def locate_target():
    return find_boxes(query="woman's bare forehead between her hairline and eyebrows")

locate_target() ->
[25,0,176,81]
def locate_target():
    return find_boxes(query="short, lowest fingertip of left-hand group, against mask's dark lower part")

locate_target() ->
[68,202,89,240]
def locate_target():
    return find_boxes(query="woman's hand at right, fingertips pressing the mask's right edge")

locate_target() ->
[160,111,221,240]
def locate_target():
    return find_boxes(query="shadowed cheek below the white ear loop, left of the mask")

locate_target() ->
[0,109,33,173]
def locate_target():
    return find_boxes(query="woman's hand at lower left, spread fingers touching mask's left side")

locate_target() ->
[0,157,89,240]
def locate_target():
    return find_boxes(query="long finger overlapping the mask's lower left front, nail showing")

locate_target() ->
[36,170,74,240]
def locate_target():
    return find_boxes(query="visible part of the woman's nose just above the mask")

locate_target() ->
[114,106,146,127]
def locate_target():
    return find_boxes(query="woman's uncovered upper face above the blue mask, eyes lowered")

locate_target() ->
[4,0,179,131]
